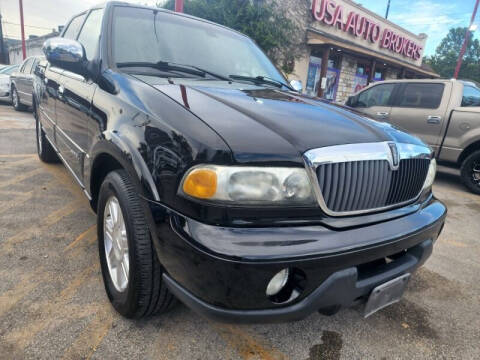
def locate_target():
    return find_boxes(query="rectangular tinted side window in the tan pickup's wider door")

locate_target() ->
[397,83,445,109]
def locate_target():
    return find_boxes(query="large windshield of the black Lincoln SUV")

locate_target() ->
[113,6,285,82]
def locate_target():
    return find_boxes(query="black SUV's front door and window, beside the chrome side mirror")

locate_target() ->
[56,9,103,185]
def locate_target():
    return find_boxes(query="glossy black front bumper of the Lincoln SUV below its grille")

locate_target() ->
[147,200,446,322]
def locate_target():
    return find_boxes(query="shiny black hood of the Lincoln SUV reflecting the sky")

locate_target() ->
[135,78,421,162]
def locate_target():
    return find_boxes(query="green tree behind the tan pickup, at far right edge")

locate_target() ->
[426,27,480,82]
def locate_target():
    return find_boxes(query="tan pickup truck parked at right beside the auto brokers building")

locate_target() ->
[347,80,480,194]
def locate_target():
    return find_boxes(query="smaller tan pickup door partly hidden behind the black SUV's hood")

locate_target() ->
[351,83,395,121]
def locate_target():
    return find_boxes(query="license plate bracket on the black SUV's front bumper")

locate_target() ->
[364,273,410,317]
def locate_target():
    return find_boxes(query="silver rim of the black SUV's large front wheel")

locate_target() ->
[103,196,130,292]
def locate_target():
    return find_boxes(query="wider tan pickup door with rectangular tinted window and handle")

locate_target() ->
[388,82,452,150]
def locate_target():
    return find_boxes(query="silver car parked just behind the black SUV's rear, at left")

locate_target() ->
[10,56,42,111]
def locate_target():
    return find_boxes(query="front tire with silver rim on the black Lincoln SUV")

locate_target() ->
[97,170,176,319]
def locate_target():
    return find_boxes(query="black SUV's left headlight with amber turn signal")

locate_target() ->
[179,165,315,205]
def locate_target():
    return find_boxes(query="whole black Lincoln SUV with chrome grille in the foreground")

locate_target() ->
[33,2,446,322]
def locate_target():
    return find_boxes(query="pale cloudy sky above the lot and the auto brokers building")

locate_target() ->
[0,0,480,55]
